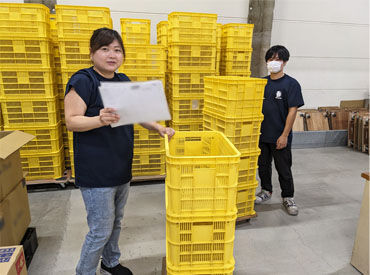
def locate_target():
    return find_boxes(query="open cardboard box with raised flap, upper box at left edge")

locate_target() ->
[0,131,34,202]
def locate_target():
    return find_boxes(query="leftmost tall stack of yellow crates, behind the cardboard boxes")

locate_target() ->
[0,3,64,183]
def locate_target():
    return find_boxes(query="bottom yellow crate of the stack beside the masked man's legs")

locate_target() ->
[236,181,258,218]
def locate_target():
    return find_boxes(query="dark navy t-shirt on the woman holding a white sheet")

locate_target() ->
[66,67,134,187]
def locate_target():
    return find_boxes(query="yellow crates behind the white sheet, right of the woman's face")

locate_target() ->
[119,18,166,177]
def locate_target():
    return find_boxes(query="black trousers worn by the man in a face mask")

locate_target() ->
[258,142,294,198]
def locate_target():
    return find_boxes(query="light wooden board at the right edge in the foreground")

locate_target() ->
[351,177,370,274]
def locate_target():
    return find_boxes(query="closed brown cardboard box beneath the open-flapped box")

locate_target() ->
[0,179,31,246]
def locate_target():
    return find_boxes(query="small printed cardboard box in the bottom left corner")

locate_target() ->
[0,245,27,275]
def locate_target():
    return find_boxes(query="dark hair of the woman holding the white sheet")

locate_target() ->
[90,28,126,58]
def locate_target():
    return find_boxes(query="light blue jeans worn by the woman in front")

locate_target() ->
[76,183,130,275]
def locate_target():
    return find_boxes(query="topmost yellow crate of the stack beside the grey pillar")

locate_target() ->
[221,23,254,49]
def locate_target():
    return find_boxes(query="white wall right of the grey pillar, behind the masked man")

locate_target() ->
[271,0,369,108]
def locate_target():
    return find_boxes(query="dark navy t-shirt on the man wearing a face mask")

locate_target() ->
[260,74,304,144]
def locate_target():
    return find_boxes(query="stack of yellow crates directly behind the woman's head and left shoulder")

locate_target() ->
[55,5,113,178]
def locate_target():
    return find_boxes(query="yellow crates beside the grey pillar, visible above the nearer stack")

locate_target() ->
[220,23,254,76]
